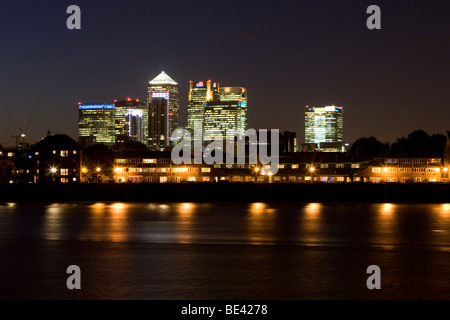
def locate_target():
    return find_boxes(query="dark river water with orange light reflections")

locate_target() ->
[0,203,450,300]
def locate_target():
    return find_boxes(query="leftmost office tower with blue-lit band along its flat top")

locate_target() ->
[78,103,115,147]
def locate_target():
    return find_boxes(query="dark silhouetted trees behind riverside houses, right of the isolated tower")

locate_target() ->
[348,130,447,158]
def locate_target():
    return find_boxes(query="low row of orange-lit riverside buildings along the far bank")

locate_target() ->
[0,134,450,183]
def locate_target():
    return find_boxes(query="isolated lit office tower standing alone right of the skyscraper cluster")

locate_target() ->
[305,105,344,144]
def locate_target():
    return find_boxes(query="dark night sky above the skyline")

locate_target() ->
[0,0,450,146]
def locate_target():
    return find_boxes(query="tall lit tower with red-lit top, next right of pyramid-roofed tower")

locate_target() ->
[186,80,220,140]
